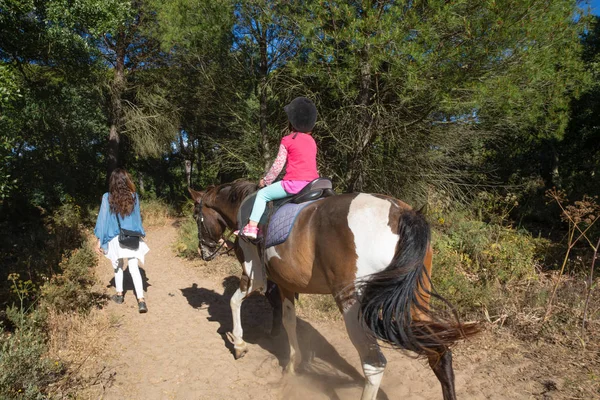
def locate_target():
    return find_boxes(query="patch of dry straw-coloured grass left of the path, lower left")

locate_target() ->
[47,310,118,398]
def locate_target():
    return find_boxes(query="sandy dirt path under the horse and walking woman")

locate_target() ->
[90,225,554,400]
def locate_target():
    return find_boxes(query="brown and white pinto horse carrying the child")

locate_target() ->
[190,181,478,400]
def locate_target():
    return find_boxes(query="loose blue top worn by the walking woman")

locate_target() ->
[94,193,146,251]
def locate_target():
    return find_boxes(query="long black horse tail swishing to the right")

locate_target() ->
[357,210,479,356]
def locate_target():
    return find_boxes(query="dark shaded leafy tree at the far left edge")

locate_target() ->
[0,1,113,208]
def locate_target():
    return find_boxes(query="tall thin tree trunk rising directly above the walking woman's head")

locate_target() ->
[106,31,127,179]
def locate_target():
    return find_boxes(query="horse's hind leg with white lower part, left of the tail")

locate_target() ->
[344,302,387,400]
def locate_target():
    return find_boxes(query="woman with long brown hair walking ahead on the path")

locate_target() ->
[94,168,150,313]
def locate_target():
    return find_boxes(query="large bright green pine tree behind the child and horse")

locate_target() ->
[293,0,587,197]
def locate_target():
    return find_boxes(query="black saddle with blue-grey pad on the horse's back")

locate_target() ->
[237,178,335,247]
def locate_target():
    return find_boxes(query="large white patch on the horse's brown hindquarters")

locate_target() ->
[348,193,399,279]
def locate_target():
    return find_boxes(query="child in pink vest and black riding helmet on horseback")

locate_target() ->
[241,97,319,239]
